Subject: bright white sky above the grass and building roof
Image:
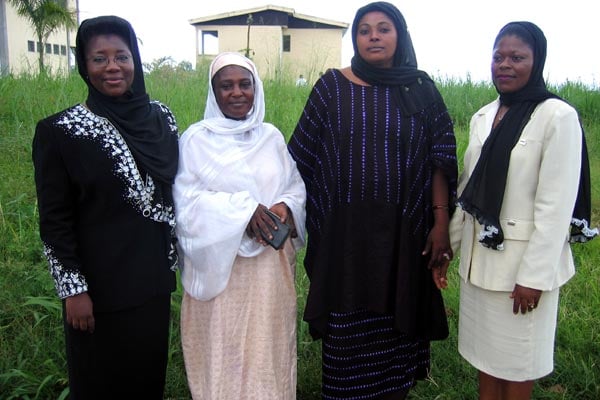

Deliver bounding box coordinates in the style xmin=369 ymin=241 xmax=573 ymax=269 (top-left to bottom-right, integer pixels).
xmin=79 ymin=0 xmax=600 ymax=87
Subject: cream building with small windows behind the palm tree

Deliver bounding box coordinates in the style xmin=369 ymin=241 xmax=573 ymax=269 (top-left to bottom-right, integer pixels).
xmin=0 ymin=0 xmax=79 ymax=75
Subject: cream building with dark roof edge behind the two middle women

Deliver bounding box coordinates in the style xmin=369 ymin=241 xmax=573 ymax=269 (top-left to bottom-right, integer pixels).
xmin=189 ymin=5 xmax=349 ymax=82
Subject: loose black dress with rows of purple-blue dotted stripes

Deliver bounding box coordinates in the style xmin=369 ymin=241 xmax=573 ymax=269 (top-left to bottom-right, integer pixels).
xmin=288 ymin=70 xmax=457 ymax=398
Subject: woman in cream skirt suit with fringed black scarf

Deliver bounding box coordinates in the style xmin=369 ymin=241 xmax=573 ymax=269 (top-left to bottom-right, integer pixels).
xmin=451 ymin=22 xmax=598 ymax=400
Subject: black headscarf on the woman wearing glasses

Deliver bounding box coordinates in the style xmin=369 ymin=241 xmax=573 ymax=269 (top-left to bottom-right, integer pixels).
xmin=75 ymin=16 xmax=178 ymax=184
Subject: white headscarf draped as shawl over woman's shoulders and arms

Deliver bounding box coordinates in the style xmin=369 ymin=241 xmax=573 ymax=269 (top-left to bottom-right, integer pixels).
xmin=173 ymin=53 xmax=306 ymax=300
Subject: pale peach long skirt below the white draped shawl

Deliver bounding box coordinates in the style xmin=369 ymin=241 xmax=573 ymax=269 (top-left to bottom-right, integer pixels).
xmin=181 ymin=241 xmax=297 ymax=400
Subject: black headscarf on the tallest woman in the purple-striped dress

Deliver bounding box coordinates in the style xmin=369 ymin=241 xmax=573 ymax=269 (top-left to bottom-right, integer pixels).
xmin=351 ymin=1 xmax=443 ymax=116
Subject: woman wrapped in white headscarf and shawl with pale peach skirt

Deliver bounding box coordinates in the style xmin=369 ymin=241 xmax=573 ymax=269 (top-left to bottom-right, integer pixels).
xmin=174 ymin=53 xmax=306 ymax=400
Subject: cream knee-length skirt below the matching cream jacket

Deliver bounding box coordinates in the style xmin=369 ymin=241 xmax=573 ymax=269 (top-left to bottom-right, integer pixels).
xmin=458 ymin=281 xmax=559 ymax=382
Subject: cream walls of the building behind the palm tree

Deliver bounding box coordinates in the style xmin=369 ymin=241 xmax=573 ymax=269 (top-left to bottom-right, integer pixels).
xmin=0 ymin=0 xmax=76 ymax=75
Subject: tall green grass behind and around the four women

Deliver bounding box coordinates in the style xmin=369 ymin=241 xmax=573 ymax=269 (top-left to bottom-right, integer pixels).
xmin=0 ymin=68 xmax=600 ymax=400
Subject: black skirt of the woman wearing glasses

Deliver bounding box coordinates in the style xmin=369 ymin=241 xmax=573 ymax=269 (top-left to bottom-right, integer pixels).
xmin=63 ymin=294 xmax=171 ymax=400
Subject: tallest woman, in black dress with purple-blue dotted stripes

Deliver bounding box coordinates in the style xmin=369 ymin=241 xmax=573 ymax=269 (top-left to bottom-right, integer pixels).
xmin=289 ymin=2 xmax=457 ymax=399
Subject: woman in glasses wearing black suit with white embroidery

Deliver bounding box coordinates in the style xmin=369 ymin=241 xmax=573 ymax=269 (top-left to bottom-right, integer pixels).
xmin=33 ymin=16 xmax=178 ymax=400
